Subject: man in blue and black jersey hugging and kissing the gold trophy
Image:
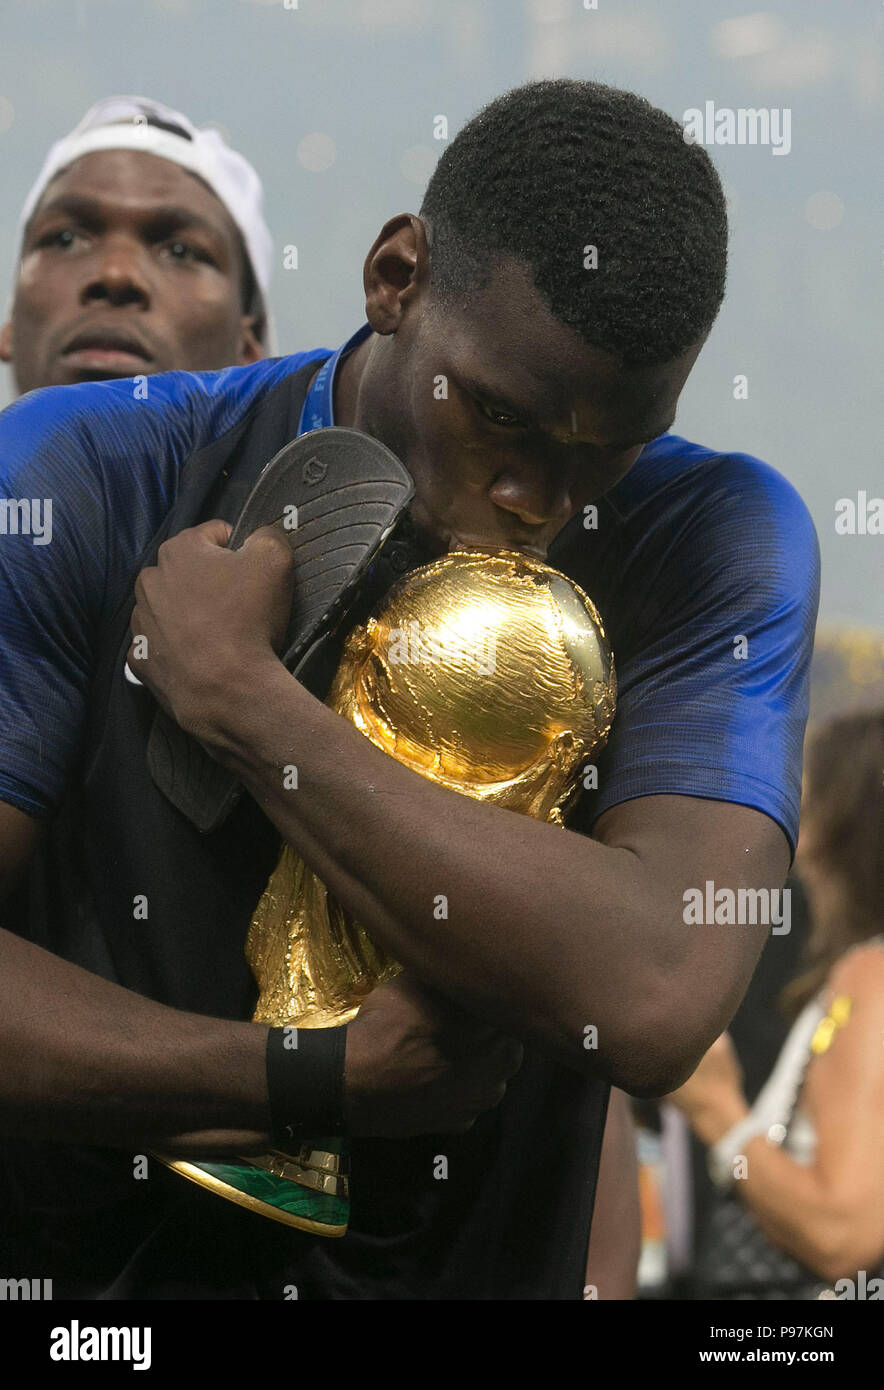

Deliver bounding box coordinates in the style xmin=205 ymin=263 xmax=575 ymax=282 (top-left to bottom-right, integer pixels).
xmin=0 ymin=82 xmax=817 ymax=1298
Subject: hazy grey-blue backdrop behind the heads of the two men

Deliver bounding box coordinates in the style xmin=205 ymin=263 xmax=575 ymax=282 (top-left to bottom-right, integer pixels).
xmin=0 ymin=0 xmax=884 ymax=627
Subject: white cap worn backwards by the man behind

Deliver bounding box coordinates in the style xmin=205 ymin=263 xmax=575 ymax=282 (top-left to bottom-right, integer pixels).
xmin=18 ymin=96 xmax=274 ymax=349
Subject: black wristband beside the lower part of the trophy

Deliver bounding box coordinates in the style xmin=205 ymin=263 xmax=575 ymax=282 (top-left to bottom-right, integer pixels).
xmin=267 ymin=1024 xmax=347 ymax=1147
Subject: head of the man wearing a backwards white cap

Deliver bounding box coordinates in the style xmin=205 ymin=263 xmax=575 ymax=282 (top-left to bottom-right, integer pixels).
xmin=0 ymin=96 xmax=272 ymax=393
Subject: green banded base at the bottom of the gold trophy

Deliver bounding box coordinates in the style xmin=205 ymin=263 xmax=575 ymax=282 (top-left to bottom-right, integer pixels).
xmin=154 ymin=1140 xmax=350 ymax=1238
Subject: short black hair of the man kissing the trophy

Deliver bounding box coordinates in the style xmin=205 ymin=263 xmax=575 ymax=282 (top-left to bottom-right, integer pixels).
xmin=420 ymin=78 xmax=727 ymax=366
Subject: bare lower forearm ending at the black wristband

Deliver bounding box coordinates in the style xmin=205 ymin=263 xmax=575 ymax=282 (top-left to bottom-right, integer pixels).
xmin=0 ymin=931 xmax=270 ymax=1156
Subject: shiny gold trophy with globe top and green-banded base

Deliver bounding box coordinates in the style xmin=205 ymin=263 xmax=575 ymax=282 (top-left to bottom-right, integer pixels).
xmin=164 ymin=550 xmax=617 ymax=1236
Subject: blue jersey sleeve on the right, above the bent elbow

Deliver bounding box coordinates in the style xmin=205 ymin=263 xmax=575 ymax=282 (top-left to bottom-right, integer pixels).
xmin=577 ymin=455 xmax=819 ymax=852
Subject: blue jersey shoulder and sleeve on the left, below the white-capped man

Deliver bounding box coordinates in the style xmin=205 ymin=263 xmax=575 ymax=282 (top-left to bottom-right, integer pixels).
xmin=0 ymin=349 xmax=327 ymax=816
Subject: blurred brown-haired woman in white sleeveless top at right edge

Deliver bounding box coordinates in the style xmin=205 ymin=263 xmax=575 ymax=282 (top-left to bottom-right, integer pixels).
xmin=669 ymin=710 xmax=884 ymax=1298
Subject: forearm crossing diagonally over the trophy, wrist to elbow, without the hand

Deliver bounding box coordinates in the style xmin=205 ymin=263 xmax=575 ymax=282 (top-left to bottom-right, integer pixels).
xmin=201 ymin=662 xmax=663 ymax=1084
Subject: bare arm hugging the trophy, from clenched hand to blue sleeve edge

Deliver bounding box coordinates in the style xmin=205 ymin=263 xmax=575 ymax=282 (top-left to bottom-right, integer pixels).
xmin=129 ymin=505 xmax=788 ymax=1095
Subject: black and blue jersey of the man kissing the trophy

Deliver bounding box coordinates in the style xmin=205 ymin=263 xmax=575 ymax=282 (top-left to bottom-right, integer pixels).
xmin=0 ymin=331 xmax=817 ymax=1300
